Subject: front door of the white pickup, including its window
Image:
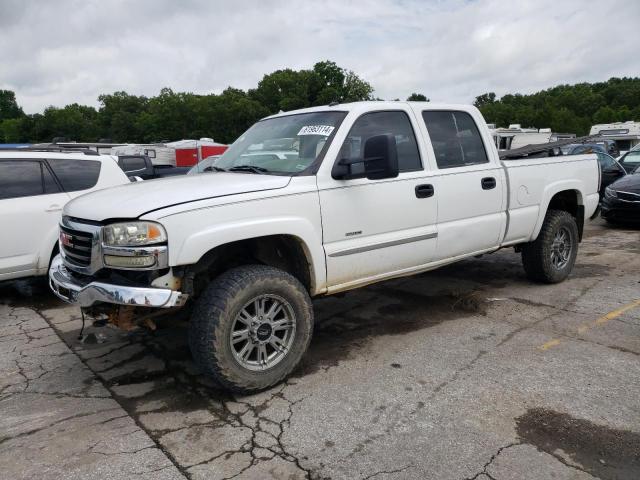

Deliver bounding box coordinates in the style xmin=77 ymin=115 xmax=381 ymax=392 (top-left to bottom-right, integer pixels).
xmin=318 ymin=107 xmax=437 ymax=291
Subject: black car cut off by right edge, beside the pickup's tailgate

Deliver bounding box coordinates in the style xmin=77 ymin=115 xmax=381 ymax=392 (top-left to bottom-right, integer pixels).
xmin=601 ymin=169 xmax=640 ymax=223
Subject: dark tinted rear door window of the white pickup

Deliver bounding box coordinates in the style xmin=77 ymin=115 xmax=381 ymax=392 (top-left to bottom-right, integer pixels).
xmin=422 ymin=111 xmax=489 ymax=168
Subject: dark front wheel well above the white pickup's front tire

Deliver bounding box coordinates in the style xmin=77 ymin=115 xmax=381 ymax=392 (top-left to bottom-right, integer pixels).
xmin=185 ymin=235 xmax=313 ymax=296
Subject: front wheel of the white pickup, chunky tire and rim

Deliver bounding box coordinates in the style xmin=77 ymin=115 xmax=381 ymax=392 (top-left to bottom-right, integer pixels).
xmin=189 ymin=265 xmax=313 ymax=393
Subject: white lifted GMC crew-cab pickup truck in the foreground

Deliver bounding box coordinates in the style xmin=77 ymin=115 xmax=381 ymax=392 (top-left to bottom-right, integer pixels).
xmin=49 ymin=102 xmax=599 ymax=392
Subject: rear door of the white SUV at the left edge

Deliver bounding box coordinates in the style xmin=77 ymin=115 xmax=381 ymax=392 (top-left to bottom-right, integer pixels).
xmin=0 ymin=160 xmax=69 ymax=280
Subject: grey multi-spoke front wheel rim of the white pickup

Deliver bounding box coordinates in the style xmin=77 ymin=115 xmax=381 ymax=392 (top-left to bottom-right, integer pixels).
xmin=229 ymin=294 xmax=296 ymax=371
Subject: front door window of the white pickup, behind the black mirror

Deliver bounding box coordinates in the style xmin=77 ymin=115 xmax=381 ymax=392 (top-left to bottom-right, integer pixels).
xmin=340 ymin=112 xmax=422 ymax=172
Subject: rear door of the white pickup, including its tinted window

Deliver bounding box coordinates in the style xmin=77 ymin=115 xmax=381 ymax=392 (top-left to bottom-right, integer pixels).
xmin=421 ymin=110 xmax=506 ymax=260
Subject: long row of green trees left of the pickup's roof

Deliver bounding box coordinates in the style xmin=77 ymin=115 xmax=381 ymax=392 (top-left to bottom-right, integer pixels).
xmin=0 ymin=61 xmax=373 ymax=143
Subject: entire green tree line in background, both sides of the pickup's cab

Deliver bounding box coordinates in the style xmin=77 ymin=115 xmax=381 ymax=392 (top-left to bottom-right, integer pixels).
xmin=5 ymin=69 xmax=640 ymax=143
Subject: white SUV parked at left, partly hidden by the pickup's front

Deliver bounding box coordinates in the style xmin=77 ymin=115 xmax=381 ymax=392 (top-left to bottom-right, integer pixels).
xmin=0 ymin=150 xmax=130 ymax=281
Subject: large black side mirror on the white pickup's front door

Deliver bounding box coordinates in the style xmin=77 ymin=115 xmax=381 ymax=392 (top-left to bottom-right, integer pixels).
xmin=331 ymin=134 xmax=398 ymax=180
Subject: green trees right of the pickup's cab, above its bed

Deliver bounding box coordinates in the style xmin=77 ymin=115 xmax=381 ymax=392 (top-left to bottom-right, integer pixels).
xmin=474 ymin=78 xmax=640 ymax=135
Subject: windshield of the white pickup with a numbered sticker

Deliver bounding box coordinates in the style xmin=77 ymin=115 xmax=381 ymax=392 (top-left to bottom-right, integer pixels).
xmin=214 ymin=112 xmax=346 ymax=175
